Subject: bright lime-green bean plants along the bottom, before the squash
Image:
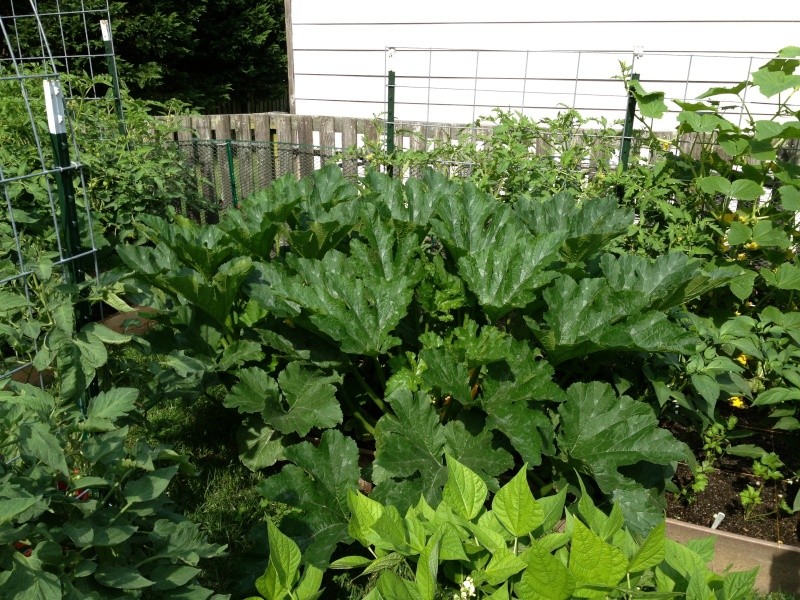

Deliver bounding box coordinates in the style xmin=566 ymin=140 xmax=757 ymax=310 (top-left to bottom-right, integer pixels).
xmin=250 ymin=458 xmax=757 ymax=600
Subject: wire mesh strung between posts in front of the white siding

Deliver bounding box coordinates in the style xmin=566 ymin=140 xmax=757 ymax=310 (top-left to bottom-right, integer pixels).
xmin=382 ymin=47 xmax=800 ymax=130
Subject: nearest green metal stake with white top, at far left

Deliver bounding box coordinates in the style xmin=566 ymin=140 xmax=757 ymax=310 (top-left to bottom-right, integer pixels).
xmin=43 ymin=79 xmax=90 ymax=411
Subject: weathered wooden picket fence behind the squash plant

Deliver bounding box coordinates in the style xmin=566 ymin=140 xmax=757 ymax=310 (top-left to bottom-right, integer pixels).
xmin=162 ymin=112 xmax=764 ymax=208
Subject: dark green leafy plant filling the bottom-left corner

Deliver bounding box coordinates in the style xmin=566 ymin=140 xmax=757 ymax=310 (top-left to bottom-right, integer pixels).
xmin=0 ymin=384 xmax=224 ymax=599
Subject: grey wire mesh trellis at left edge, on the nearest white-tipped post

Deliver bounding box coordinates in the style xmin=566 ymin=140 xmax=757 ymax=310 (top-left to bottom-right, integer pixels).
xmin=0 ymin=0 xmax=108 ymax=384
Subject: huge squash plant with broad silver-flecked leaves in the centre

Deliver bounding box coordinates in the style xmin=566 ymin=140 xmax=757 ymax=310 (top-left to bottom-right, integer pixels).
xmin=119 ymin=165 xmax=740 ymax=566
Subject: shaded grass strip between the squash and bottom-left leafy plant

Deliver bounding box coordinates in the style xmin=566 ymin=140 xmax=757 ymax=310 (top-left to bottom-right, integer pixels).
xmin=112 ymin=346 xmax=290 ymax=598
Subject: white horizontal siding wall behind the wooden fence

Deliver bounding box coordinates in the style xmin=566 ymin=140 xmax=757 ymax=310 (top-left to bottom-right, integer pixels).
xmin=290 ymin=0 xmax=800 ymax=126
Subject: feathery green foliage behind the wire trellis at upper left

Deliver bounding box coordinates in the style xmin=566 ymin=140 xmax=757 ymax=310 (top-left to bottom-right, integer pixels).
xmin=0 ymin=67 xmax=205 ymax=266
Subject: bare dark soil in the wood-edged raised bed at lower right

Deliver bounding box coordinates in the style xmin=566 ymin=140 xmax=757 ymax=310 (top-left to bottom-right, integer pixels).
xmin=667 ymin=418 xmax=800 ymax=547
